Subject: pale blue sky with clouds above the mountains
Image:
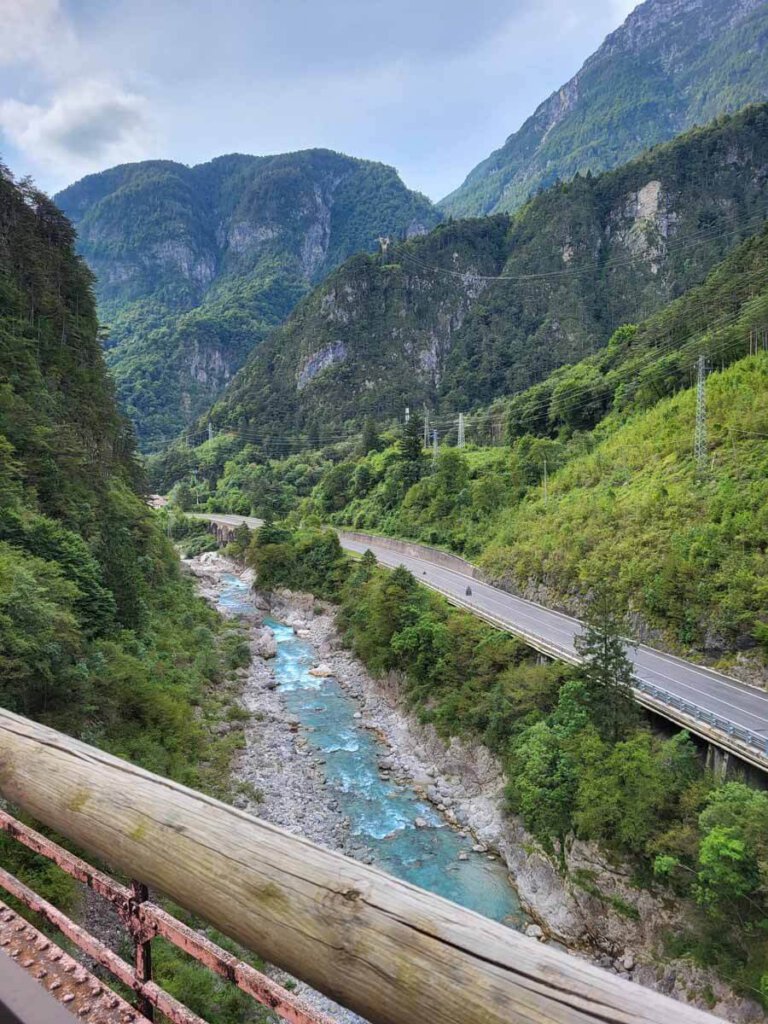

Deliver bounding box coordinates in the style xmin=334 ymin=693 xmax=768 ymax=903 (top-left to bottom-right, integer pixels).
xmin=0 ymin=0 xmax=636 ymax=200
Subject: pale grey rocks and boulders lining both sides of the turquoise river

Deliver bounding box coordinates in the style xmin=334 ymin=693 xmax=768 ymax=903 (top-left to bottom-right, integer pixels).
xmin=191 ymin=555 xmax=766 ymax=1024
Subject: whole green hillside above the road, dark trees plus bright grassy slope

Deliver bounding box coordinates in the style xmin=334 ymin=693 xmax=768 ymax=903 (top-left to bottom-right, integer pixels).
xmin=290 ymin=221 xmax=768 ymax=658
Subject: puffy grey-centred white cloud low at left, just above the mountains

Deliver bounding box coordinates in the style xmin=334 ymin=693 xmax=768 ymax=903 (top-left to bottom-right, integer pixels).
xmin=0 ymin=80 xmax=154 ymax=176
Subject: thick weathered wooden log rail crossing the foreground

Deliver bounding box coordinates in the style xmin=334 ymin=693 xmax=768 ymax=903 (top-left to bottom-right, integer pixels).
xmin=0 ymin=711 xmax=714 ymax=1024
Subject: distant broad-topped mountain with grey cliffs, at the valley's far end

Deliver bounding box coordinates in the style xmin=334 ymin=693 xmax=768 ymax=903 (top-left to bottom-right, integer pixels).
xmin=55 ymin=150 xmax=439 ymax=446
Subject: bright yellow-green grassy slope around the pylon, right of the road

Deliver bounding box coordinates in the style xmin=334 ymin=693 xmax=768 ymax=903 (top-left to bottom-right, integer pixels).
xmin=482 ymin=353 xmax=768 ymax=649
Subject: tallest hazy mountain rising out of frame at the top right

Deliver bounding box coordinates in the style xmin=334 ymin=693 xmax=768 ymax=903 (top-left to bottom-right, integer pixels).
xmin=438 ymin=0 xmax=768 ymax=217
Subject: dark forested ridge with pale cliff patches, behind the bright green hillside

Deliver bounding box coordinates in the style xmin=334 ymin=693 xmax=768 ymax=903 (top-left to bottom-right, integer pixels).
xmin=204 ymin=105 xmax=768 ymax=440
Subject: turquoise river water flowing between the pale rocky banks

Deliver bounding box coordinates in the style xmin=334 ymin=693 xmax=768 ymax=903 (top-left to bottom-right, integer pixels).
xmin=217 ymin=572 xmax=526 ymax=929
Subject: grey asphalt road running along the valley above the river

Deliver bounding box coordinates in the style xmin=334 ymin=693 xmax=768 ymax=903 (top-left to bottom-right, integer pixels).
xmin=196 ymin=515 xmax=768 ymax=764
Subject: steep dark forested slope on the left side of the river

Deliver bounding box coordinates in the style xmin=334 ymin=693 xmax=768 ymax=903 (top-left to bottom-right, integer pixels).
xmin=0 ymin=168 xmax=270 ymax=1024
